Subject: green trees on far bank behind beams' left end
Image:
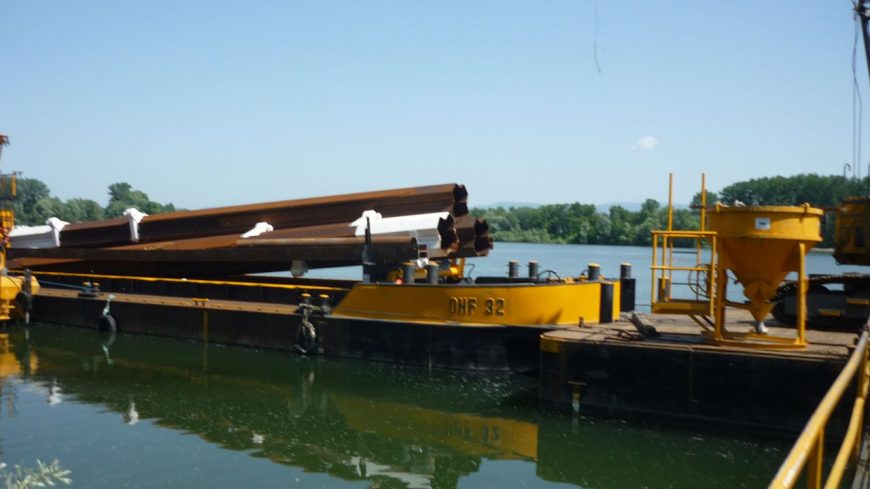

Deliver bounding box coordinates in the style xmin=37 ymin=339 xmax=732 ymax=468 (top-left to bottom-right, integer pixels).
xmin=12 ymin=178 xmax=176 ymax=226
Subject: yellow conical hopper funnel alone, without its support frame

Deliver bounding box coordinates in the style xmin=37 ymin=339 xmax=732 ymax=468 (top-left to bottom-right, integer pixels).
xmin=709 ymin=204 xmax=823 ymax=321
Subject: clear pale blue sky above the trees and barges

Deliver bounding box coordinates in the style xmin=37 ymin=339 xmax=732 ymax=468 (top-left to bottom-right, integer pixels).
xmin=0 ymin=0 xmax=870 ymax=208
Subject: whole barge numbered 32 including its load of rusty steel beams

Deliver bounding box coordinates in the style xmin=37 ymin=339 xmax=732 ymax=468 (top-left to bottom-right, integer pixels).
xmin=3 ymin=153 xmax=633 ymax=371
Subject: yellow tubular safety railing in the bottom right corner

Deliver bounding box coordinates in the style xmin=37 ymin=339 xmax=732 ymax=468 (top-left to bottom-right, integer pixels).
xmin=770 ymin=321 xmax=870 ymax=489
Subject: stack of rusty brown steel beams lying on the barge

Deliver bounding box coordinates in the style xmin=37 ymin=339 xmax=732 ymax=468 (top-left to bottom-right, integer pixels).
xmin=10 ymin=184 xmax=492 ymax=277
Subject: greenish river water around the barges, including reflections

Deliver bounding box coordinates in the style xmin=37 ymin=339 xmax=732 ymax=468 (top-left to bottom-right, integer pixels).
xmin=0 ymin=243 xmax=860 ymax=489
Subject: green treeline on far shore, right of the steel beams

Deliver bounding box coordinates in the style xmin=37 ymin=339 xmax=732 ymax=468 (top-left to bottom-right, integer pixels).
xmin=472 ymin=174 xmax=870 ymax=246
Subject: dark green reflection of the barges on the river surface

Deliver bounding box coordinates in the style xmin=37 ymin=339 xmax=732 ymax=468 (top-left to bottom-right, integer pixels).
xmin=0 ymin=326 xmax=785 ymax=488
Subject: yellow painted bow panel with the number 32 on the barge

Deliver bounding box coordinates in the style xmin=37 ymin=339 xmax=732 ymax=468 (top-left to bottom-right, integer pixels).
xmin=333 ymin=281 xmax=619 ymax=326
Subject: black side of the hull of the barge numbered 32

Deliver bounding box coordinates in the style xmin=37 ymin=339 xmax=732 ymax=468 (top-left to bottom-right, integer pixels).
xmin=32 ymin=295 xmax=552 ymax=372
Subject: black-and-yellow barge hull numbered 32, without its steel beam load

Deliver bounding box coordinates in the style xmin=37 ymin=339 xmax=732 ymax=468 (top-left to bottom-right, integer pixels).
xmin=27 ymin=266 xmax=621 ymax=371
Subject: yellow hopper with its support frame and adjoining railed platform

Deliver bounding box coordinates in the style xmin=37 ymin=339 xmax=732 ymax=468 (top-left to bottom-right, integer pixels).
xmin=650 ymin=175 xmax=823 ymax=348
